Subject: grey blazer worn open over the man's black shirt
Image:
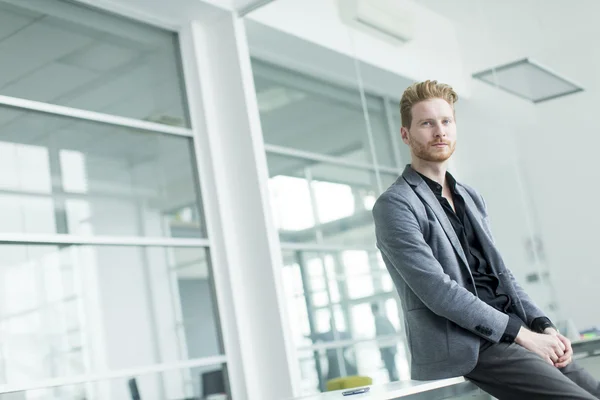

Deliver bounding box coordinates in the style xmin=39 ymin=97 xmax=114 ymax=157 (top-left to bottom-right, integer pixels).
xmin=373 ymin=166 xmax=544 ymax=380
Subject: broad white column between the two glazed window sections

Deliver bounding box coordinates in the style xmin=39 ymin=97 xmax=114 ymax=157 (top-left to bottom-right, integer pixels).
xmin=181 ymin=11 xmax=299 ymax=400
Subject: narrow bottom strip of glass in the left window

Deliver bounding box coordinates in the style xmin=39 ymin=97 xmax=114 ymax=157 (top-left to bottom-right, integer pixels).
xmin=8 ymin=365 xmax=229 ymax=400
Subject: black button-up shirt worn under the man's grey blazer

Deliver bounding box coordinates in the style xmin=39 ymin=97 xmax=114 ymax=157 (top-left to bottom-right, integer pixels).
xmin=419 ymin=172 xmax=553 ymax=347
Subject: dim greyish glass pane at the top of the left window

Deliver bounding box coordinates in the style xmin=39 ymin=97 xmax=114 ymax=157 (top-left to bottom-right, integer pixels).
xmin=0 ymin=0 xmax=188 ymax=126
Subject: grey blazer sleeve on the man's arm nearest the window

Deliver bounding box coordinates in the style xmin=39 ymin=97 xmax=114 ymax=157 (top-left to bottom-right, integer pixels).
xmin=373 ymin=191 xmax=509 ymax=343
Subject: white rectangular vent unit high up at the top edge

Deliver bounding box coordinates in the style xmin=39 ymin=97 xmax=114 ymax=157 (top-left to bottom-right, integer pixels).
xmin=338 ymin=0 xmax=414 ymax=45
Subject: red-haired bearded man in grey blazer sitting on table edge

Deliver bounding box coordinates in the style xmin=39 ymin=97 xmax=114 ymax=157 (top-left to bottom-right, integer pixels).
xmin=373 ymin=81 xmax=600 ymax=400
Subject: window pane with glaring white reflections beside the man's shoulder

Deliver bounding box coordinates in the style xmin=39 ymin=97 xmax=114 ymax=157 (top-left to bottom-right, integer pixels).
xmin=267 ymin=154 xmax=379 ymax=246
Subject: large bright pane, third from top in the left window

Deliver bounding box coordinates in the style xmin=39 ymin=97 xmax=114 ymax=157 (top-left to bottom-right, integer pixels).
xmin=0 ymin=245 xmax=221 ymax=384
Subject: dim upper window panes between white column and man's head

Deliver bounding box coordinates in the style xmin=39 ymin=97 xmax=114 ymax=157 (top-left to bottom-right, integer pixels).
xmin=252 ymin=60 xmax=394 ymax=165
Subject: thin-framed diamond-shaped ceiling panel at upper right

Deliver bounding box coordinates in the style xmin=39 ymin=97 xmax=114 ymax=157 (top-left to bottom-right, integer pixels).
xmin=473 ymin=58 xmax=583 ymax=103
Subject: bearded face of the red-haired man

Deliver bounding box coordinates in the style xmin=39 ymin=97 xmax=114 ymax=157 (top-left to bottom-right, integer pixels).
xmin=401 ymin=99 xmax=456 ymax=162
